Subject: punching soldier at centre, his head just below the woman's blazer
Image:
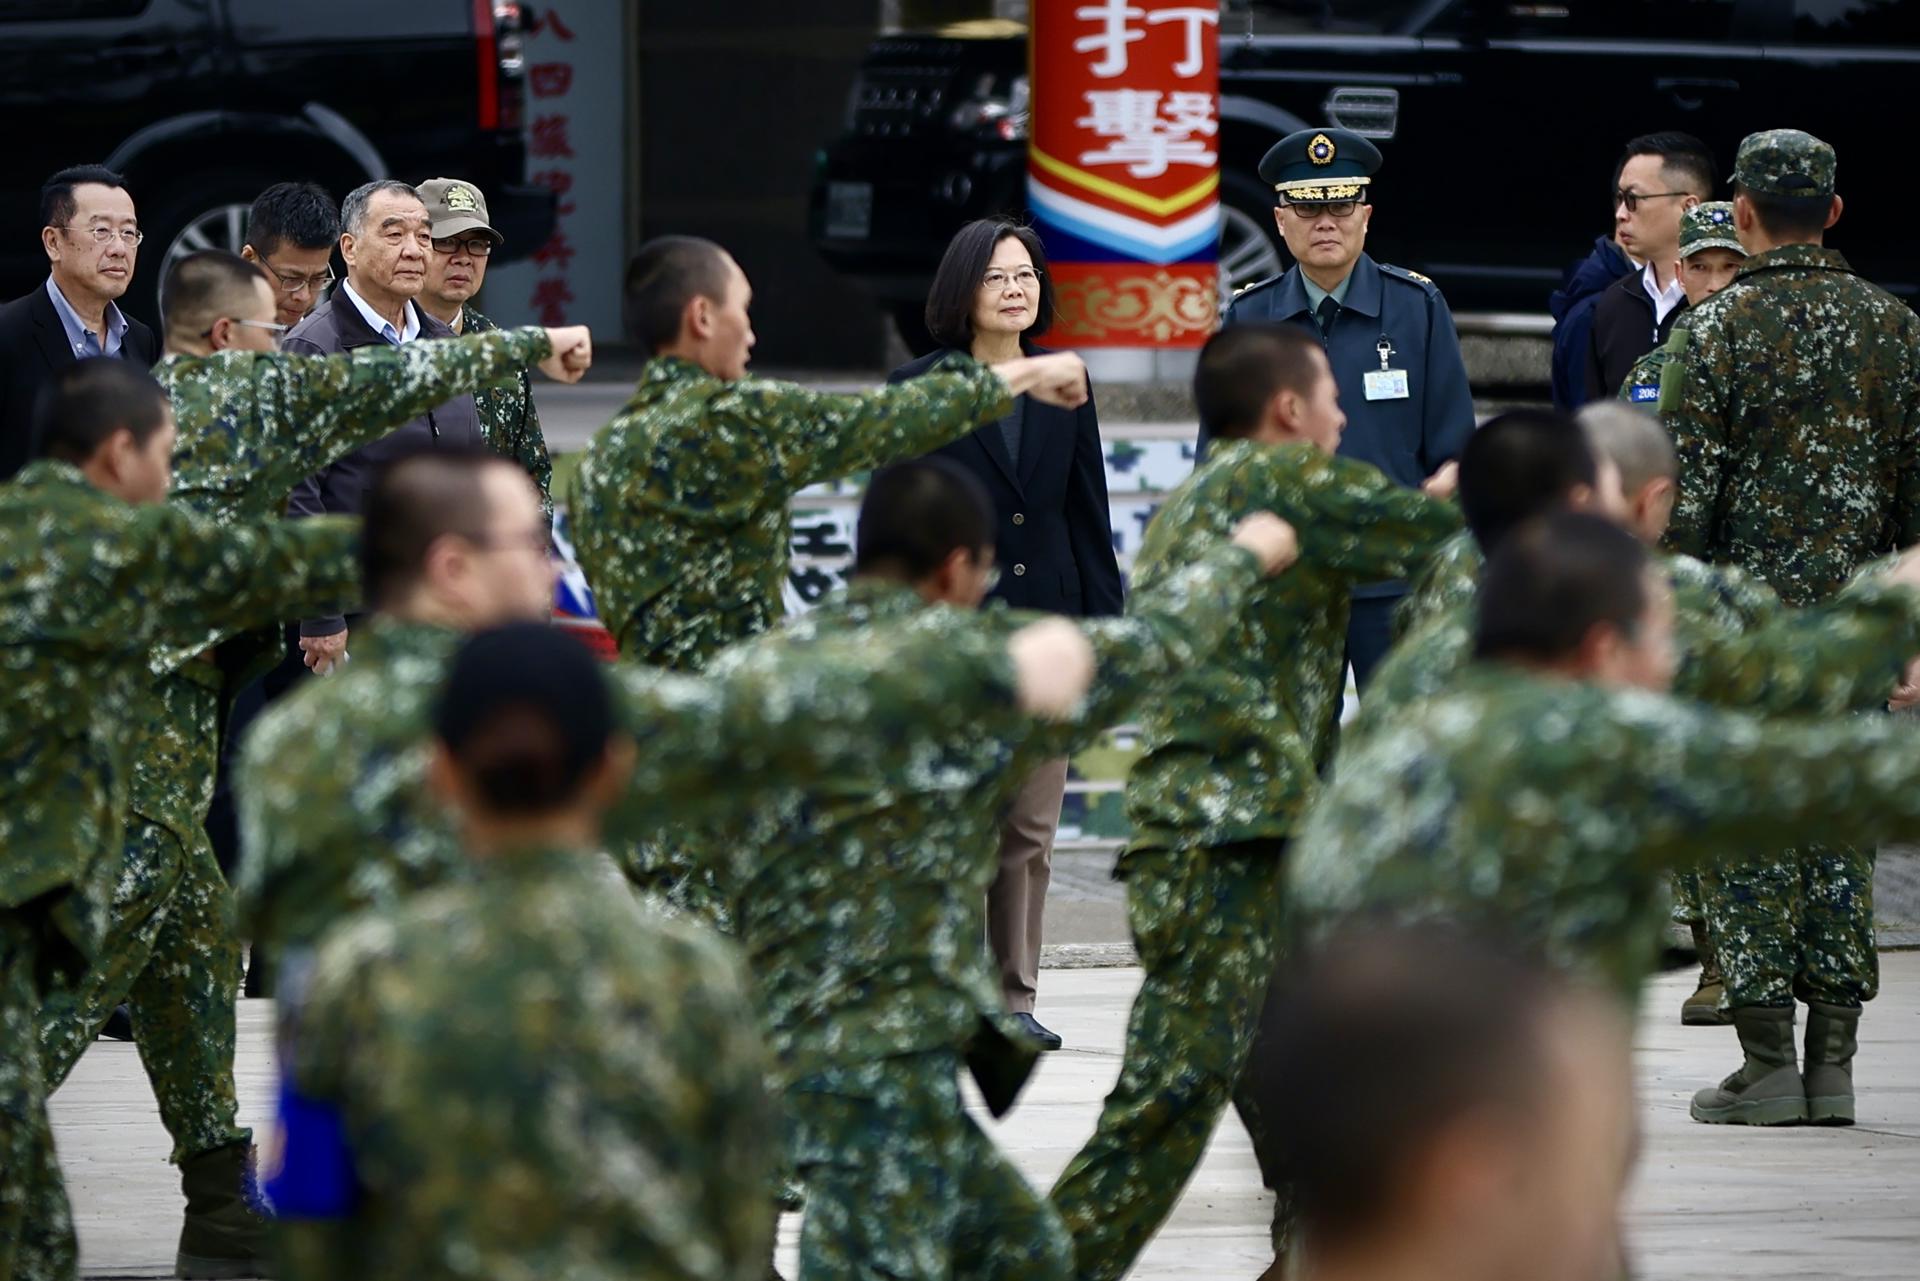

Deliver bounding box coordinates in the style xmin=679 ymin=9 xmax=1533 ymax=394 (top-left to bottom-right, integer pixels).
xmin=708 ymin=459 xmax=1294 ymax=1281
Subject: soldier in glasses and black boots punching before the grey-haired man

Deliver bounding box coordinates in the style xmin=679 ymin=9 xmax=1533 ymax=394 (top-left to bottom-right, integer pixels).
xmin=24 ymin=250 xmax=586 ymax=1275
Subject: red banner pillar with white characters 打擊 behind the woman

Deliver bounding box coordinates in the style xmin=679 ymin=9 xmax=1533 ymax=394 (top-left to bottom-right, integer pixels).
xmin=1027 ymin=0 xmax=1219 ymax=348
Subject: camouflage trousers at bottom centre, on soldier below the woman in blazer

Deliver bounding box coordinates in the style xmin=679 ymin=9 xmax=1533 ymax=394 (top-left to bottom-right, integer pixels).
xmin=785 ymin=1051 xmax=1073 ymax=1281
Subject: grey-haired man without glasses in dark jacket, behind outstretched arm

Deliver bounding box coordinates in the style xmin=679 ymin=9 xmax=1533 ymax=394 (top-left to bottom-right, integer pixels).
xmin=284 ymin=179 xmax=486 ymax=670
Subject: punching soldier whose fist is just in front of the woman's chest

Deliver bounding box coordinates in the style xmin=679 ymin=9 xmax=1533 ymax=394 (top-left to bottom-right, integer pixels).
xmin=568 ymin=236 xmax=1087 ymax=924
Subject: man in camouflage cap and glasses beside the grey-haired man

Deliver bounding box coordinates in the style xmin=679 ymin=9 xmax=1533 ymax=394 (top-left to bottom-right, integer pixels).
xmin=420 ymin=179 xmax=553 ymax=520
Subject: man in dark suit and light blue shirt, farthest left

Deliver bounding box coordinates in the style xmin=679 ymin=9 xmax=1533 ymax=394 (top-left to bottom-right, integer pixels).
xmin=0 ymin=165 xmax=159 ymax=480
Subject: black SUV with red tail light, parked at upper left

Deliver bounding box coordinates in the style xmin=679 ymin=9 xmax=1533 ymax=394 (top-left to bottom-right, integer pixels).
xmin=0 ymin=0 xmax=555 ymax=323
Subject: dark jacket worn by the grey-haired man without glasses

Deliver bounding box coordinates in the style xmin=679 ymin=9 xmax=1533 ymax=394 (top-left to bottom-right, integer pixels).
xmin=282 ymin=282 xmax=486 ymax=636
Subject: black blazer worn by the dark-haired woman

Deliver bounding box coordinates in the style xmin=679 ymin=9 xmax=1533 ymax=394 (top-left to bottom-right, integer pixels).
xmin=887 ymin=344 xmax=1125 ymax=616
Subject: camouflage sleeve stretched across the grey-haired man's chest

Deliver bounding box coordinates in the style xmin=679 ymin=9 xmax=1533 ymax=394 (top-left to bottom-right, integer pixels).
xmin=253 ymin=326 xmax=553 ymax=494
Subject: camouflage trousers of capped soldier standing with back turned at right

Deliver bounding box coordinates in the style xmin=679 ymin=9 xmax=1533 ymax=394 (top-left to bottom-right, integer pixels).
xmin=1703 ymin=845 xmax=1880 ymax=1006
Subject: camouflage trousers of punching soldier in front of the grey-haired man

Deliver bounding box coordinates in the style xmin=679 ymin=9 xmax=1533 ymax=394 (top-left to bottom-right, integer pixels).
xmin=40 ymin=814 xmax=253 ymax=1164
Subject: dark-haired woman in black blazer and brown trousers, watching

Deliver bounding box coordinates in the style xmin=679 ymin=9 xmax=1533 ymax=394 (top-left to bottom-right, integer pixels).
xmin=891 ymin=219 xmax=1125 ymax=1049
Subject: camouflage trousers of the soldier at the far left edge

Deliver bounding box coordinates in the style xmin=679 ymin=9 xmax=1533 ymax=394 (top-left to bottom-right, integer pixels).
xmin=0 ymin=908 xmax=81 ymax=1281
